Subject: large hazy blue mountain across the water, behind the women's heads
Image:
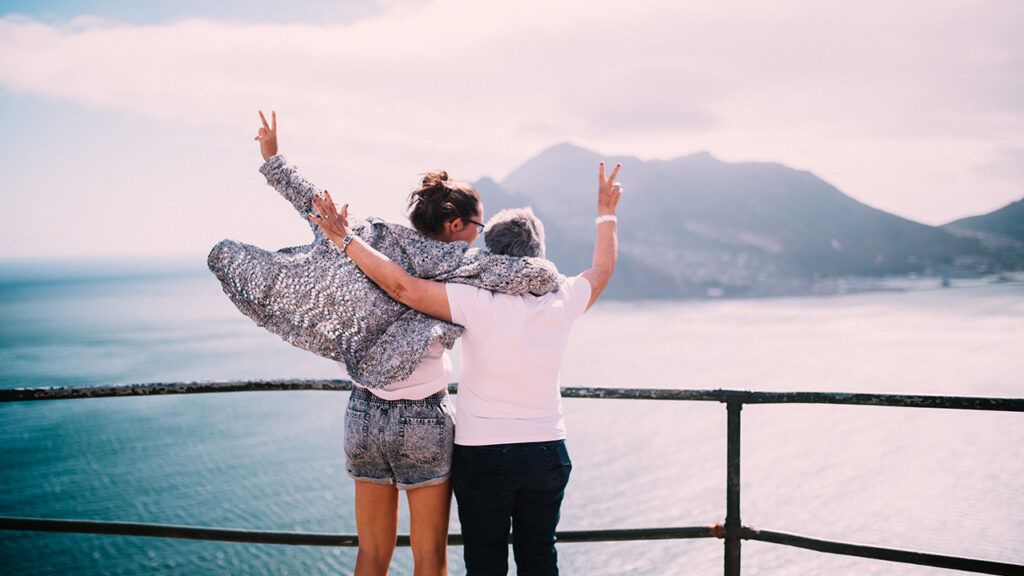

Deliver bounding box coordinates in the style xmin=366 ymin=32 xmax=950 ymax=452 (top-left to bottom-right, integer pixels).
xmin=475 ymin=143 xmax=995 ymax=297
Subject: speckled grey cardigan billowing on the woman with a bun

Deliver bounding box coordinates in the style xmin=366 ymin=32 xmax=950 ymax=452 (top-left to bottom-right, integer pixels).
xmin=207 ymin=156 xmax=561 ymax=388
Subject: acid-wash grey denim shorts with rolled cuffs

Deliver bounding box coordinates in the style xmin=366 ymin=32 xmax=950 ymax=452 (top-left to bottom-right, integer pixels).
xmin=345 ymin=386 xmax=455 ymax=490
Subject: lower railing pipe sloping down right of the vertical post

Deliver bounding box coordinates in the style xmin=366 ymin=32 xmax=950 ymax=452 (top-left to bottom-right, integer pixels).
xmin=743 ymin=527 xmax=1024 ymax=576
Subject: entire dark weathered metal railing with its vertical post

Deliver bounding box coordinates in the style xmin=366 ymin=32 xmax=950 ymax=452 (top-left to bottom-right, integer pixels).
xmin=0 ymin=380 xmax=1024 ymax=576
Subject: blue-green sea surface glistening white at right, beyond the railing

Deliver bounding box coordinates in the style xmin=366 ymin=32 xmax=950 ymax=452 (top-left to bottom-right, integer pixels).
xmin=0 ymin=263 xmax=1024 ymax=575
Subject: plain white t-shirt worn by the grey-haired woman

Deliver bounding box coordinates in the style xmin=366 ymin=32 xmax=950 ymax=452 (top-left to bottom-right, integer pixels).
xmin=445 ymin=276 xmax=591 ymax=446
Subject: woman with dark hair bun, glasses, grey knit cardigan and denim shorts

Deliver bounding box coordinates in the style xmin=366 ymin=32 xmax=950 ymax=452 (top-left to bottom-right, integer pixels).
xmin=208 ymin=112 xmax=559 ymax=576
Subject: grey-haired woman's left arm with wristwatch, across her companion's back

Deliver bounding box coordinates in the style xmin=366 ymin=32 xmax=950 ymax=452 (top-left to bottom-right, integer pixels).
xmin=309 ymin=191 xmax=452 ymax=322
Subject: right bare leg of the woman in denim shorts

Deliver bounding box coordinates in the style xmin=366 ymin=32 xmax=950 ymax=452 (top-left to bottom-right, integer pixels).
xmin=407 ymin=481 xmax=452 ymax=576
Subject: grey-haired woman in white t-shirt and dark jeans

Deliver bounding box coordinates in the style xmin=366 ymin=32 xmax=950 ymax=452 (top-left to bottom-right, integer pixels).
xmin=309 ymin=162 xmax=622 ymax=576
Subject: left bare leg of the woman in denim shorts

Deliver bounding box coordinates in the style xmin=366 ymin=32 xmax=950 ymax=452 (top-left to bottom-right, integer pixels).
xmin=354 ymin=481 xmax=397 ymax=576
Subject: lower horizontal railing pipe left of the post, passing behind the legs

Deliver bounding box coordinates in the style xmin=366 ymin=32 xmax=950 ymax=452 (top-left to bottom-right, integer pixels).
xmin=0 ymin=517 xmax=714 ymax=546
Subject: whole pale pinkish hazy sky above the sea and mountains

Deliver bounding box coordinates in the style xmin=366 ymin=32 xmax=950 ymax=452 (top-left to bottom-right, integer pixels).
xmin=0 ymin=0 xmax=1024 ymax=257
